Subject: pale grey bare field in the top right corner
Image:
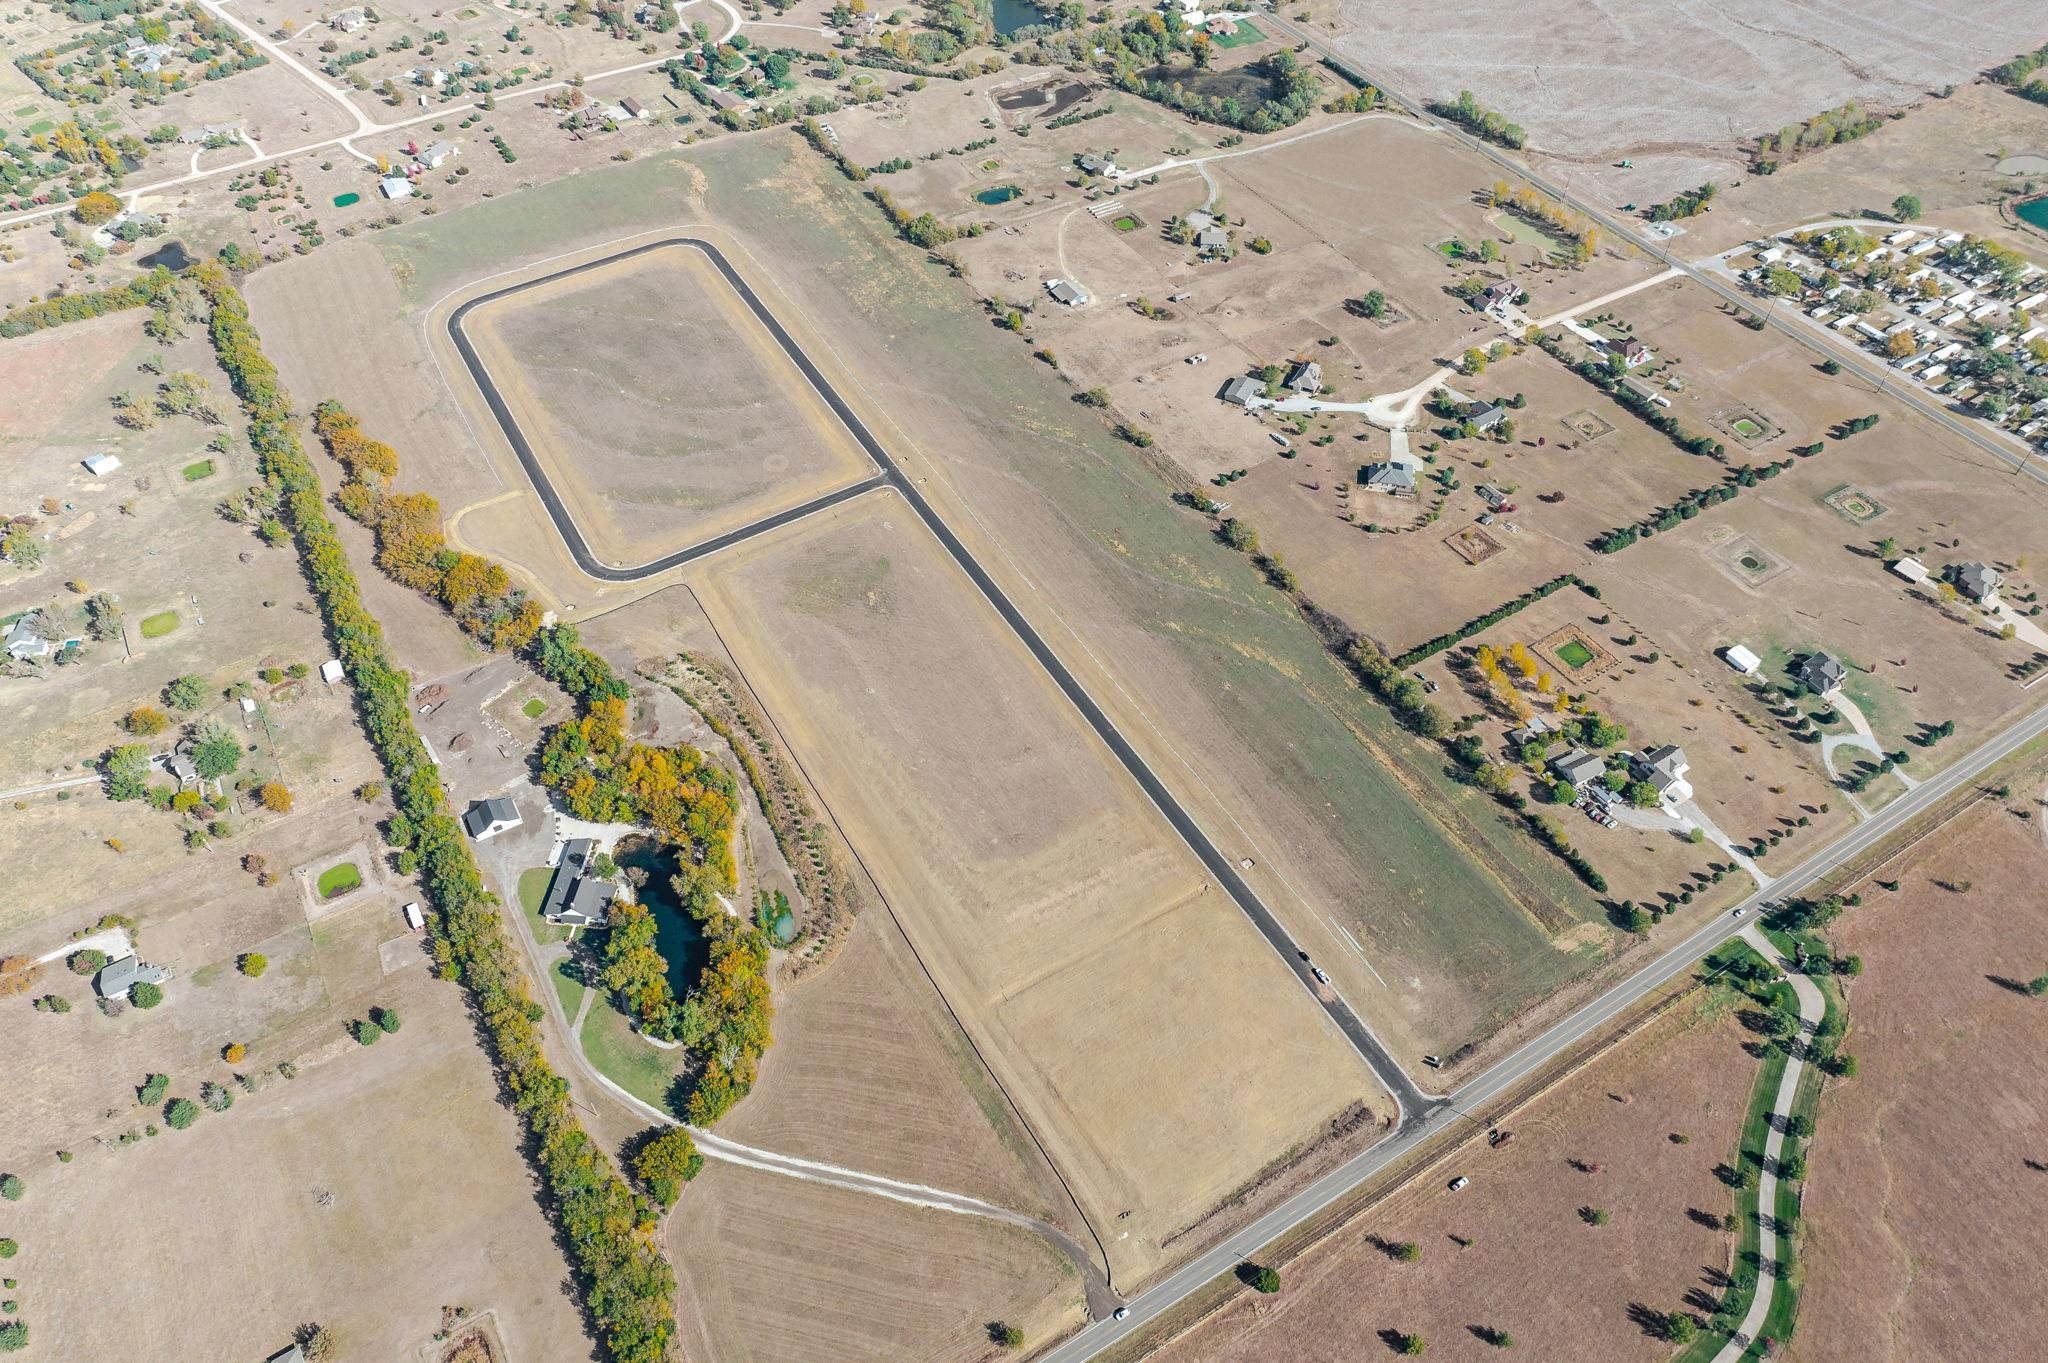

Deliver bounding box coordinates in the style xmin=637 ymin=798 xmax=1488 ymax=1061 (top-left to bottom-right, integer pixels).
xmin=1335 ymin=0 xmax=2042 ymax=201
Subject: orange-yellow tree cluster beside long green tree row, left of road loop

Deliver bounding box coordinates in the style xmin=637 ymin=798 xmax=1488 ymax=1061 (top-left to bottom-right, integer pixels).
xmin=313 ymin=401 xmax=545 ymax=649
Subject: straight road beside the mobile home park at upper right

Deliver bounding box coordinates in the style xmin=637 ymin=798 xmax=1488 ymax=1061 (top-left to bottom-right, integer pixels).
xmin=1260 ymin=14 xmax=2048 ymax=483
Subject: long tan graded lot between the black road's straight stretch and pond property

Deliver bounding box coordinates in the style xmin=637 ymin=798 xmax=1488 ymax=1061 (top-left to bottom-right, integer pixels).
xmin=700 ymin=495 xmax=1386 ymax=1281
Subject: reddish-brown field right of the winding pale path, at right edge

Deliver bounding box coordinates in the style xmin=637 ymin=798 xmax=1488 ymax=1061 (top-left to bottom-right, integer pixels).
xmin=1790 ymin=798 xmax=2048 ymax=1363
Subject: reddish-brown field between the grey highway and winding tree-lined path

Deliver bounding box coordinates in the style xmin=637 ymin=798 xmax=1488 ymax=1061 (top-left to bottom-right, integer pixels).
xmin=1153 ymin=1003 xmax=1755 ymax=1363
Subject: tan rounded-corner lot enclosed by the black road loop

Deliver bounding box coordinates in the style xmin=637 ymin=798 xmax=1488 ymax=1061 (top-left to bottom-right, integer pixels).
xmin=467 ymin=246 xmax=872 ymax=563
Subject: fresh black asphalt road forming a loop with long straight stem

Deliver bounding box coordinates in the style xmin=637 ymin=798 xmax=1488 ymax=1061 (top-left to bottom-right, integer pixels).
xmin=449 ymin=237 xmax=1434 ymax=1119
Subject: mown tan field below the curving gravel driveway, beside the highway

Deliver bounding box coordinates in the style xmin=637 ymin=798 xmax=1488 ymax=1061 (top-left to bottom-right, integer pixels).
xmin=668 ymin=1154 xmax=1081 ymax=1361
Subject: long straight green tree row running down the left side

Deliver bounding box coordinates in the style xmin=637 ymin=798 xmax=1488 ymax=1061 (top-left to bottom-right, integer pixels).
xmin=193 ymin=262 xmax=676 ymax=1363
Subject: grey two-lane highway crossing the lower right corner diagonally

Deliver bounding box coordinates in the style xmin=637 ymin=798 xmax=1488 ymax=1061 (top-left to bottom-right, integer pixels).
xmin=1040 ymin=691 xmax=2048 ymax=1363
